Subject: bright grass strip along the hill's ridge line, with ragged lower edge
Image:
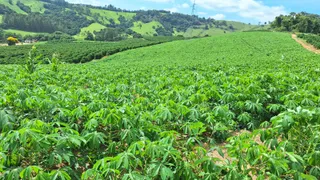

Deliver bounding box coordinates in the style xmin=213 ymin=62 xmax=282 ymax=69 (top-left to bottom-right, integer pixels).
xmin=90 ymin=8 xmax=136 ymax=24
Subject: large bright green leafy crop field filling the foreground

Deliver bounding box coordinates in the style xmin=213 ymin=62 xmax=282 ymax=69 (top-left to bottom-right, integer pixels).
xmin=0 ymin=32 xmax=320 ymax=180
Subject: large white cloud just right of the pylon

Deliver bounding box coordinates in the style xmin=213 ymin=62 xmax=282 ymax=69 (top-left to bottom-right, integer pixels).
xmin=190 ymin=0 xmax=287 ymax=22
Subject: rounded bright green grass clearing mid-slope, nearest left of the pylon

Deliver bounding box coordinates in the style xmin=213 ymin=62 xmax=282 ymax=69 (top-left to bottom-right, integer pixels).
xmin=131 ymin=21 xmax=162 ymax=36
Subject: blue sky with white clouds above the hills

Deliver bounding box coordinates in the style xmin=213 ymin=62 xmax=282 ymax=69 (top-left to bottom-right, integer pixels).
xmin=66 ymin=0 xmax=320 ymax=24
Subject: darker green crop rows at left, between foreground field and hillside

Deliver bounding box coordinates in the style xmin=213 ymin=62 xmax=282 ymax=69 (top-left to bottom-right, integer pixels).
xmin=0 ymin=37 xmax=183 ymax=64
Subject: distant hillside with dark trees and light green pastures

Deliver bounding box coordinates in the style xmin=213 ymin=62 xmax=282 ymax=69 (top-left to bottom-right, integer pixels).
xmin=0 ymin=0 xmax=269 ymax=39
